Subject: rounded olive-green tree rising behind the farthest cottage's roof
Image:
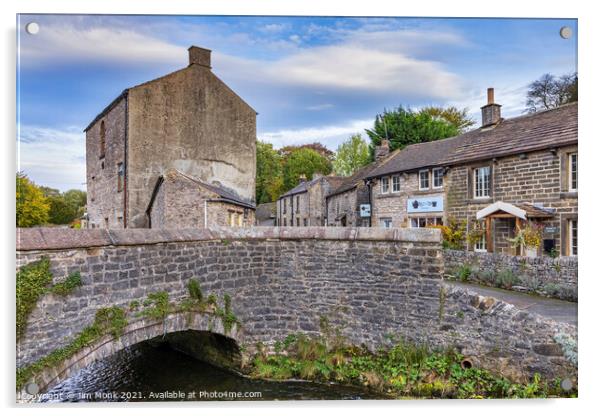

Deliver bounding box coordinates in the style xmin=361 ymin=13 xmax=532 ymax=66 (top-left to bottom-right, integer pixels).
xmin=283 ymin=148 xmax=332 ymax=192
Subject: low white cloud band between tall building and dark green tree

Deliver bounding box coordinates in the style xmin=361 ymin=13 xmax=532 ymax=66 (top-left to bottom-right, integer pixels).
xmin=259 ymin=119 xmax=374 ymax=150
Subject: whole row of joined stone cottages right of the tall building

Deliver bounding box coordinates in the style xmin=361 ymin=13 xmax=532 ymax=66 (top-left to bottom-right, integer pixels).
xmin=276 ymin=89 xmax=578 ymax=256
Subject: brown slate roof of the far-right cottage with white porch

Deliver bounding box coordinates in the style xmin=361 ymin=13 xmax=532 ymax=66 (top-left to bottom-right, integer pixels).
xmin=442 ymin=102 xmax=578 ymax=165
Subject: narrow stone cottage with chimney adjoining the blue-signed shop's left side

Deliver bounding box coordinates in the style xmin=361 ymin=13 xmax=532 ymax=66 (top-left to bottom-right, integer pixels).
xmin=326 ymin=140 xmax=398 ymax=227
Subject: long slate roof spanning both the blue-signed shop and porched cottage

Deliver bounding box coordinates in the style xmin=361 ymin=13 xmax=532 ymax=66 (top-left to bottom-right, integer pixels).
xmin=368 ymin=102 xmax=577 ymax=178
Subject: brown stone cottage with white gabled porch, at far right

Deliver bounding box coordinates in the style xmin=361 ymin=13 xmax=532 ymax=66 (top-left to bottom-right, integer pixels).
xmin=442 ymin=89 xmax=578 ymax=256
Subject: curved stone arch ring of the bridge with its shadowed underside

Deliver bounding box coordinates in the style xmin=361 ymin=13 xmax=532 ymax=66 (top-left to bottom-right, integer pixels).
xmin=24 ymin=312 xmax=243 ymax=396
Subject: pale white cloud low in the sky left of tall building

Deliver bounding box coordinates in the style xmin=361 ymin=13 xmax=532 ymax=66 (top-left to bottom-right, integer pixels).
xmin=17 ymin=126 xmax=86 ymax=191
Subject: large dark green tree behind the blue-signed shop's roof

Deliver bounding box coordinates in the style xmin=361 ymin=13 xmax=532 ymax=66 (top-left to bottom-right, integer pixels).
xmin=366 ymin=106 xmax=461 ymax=153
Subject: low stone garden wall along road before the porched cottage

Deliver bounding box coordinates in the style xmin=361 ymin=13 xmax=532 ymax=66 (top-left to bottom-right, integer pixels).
xmin=443 ymin=250 xmax=578 ymax=301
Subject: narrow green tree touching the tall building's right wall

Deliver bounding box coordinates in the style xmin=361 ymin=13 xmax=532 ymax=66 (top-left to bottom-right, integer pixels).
xmin=255 ymin=140 xmax=284 ymax=204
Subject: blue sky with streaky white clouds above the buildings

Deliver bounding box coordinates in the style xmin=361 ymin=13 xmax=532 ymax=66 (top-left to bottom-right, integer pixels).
xmin=17 ymin=15 xmax=577 ymax=191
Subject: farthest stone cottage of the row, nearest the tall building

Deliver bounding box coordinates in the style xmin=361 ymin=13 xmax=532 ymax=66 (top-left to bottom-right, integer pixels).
xmin=276 ymin=173 xmax=343 ymax=227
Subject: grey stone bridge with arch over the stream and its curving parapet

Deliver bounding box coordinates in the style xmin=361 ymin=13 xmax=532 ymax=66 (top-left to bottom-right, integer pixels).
xmin=17 ymin=227 xmax=576 ymax=400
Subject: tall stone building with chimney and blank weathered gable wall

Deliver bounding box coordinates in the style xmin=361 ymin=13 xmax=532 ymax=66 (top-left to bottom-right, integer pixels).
xmin=85 ymin=46 xmax=257 ymax=228
